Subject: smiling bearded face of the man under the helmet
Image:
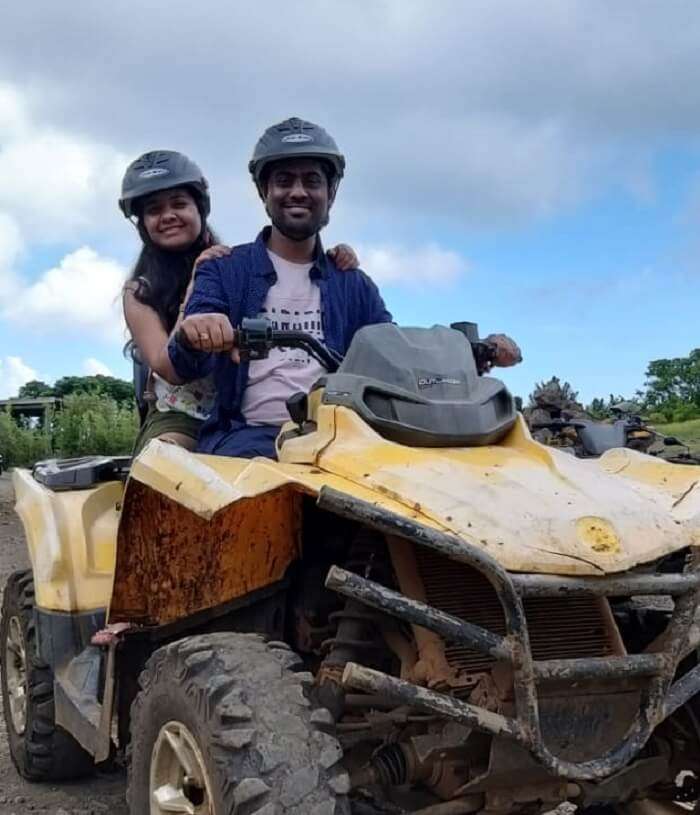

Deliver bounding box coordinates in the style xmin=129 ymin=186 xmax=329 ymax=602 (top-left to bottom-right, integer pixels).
xmin=264 ymin=158 xmax=333 ymax=241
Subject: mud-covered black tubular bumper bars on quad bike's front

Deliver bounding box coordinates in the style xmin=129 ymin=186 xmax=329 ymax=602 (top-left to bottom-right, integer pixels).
xmin=318 ymin=487 xmax=700 ymax=780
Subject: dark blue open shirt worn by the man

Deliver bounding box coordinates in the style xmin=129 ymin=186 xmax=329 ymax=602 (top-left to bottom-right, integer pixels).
xmin=168 ymin=227 xmax=392 ymax=453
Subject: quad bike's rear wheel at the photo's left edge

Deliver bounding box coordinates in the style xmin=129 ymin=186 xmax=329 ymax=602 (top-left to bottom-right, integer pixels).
xmin=0 ymin=571 xmax=95 ymax=781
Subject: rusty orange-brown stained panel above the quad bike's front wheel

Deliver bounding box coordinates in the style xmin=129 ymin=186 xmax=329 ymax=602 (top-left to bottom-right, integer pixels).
xmin=109 ymin=481 xmax=301 ymax=625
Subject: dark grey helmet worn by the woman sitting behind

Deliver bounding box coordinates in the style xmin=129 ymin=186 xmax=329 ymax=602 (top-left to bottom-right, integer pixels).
xmin=119 ymin=150 xmax=211 ymax=218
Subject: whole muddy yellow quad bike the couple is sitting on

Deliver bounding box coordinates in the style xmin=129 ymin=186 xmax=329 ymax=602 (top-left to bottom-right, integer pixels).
xmin=0 ymin=322 xmax=700 ymax=815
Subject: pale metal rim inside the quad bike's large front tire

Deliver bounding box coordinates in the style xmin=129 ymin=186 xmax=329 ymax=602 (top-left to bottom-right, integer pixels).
xmin=150 ymin=721 xmax=214 ymax=815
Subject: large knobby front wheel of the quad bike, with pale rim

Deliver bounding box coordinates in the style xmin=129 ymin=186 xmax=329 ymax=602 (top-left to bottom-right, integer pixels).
xmin=127 ymin=633 xmax=350 ymax=815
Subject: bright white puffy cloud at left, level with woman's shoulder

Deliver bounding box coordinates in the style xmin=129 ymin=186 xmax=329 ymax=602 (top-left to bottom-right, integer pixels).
xmin=2 ymin=246 xmax=126 ymax=342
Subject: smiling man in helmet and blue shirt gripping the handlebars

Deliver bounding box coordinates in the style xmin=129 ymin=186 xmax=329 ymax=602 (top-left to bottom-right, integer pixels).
xmin=167 ymin=118 xmax=519 ymax=458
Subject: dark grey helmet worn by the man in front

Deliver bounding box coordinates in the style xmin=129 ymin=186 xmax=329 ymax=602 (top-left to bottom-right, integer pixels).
xmin=248 ymin=116 xmax=345 ymax=189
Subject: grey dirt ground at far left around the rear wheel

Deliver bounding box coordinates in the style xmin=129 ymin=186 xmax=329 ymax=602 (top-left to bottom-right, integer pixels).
xmin=0 ymin=473 xmax=128 ymax=815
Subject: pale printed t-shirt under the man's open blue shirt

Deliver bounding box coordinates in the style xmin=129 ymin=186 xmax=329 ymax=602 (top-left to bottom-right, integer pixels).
xmin=242 ymin=250 xmax=326 ymax=425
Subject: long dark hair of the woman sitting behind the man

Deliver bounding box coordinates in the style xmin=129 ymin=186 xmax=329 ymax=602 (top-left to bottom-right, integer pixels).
xmin=127 ymin=190 xmax=219 ymax=338
